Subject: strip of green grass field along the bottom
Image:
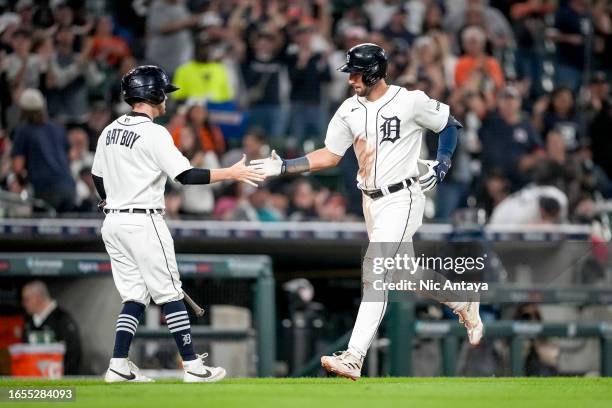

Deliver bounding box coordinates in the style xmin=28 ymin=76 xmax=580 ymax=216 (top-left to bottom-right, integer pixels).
xmin=0 ymin=378 xmax=612 ymax=408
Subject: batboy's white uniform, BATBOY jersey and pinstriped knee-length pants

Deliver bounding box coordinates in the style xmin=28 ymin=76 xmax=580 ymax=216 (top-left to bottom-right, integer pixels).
xmin=91 ymin=113 xmax=192 ymax=305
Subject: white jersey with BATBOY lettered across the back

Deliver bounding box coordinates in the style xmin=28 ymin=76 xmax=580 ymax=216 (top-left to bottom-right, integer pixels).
xmin=91 ymin=113 xmax=192 ymax=209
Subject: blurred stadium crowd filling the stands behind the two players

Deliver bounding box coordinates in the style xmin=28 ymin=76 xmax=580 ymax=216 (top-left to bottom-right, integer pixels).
xmin=0 ymin=0 xmax=612 ymax=224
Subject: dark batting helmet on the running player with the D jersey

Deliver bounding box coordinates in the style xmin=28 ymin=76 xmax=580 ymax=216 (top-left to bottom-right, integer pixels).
xmin=338 ymin=43 xmax=387 ymax=86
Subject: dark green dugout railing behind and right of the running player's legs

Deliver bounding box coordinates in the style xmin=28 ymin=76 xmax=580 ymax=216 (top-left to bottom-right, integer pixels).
xmin=292 ymin=286 xmax=612 ymax=377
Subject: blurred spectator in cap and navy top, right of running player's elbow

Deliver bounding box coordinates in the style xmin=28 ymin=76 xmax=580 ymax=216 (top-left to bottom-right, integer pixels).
xmin=479 ymin=86 xmax=544 ymax=190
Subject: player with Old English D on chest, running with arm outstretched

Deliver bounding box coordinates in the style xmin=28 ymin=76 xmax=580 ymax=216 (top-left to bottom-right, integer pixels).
xmin=249 ymin=43 xmax=483 ymax=380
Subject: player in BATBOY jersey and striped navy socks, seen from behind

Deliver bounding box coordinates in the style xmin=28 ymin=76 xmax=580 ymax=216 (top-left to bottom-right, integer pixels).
xmin=91 ymin=65 xmax=264 ymax=382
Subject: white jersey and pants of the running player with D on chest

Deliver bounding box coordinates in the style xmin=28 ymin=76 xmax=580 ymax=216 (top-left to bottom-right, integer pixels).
xmin=325 ymin=86 xmax=449 ymax=357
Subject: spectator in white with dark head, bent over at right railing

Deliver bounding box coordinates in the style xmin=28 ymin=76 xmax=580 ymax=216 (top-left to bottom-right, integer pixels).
xmin=490 ymin=161 xmax=569 ymax=225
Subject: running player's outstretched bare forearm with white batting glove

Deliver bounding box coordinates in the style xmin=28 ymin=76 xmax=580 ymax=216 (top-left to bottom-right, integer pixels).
xmin=249 ymin=147 xmax=342 ymax=177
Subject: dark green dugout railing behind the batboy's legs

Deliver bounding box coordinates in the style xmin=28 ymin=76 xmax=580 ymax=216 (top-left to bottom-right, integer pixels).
xmin=0 ymin=253 xmax=276 ymax=377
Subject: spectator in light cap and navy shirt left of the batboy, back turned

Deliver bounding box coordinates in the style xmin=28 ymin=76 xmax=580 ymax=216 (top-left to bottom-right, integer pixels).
xmin=11 ymin=89 xmax=75 ymax=212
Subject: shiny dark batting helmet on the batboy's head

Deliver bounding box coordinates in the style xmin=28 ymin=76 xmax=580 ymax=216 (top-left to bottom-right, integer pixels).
xmin=121 ymin=65 xmax=178 ymax=105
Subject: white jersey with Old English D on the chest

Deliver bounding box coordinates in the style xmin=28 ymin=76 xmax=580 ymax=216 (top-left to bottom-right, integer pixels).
xmin=325 ymin=85 xmax=449 ymax=190
